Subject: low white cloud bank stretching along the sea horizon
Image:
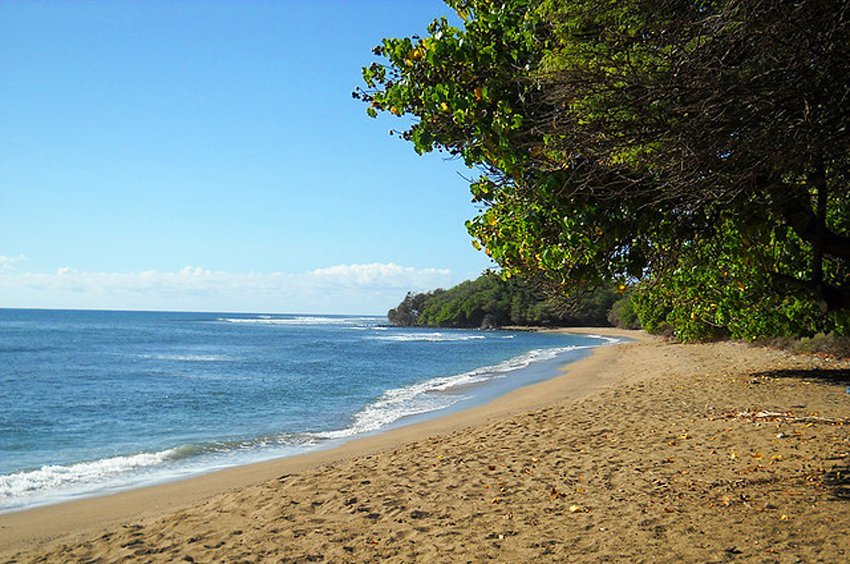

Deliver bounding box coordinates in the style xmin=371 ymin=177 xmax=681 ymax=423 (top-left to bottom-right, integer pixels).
xmin=0 ymin=264 xmax=458 ymax=314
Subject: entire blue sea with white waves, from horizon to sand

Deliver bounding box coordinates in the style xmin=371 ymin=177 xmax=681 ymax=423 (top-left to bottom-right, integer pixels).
xmin=0 ymin=310 xmax=606 ymax=512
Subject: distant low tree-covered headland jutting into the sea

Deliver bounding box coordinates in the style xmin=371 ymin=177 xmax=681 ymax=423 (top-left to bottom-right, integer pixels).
xmin=387 ymin=273 xmax=620 ymax=328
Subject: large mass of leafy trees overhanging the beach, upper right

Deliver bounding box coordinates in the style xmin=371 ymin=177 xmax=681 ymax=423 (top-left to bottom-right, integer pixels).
xmin=354 ymin=0 xmax=850 ymax=341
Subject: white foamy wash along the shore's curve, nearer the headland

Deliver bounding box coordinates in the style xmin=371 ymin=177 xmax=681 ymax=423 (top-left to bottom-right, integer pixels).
xmin=318 ymin=346 xmax=592 ymax=439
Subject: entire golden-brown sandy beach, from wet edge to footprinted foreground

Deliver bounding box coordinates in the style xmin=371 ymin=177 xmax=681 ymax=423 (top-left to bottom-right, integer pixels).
xmin=0 ymin=330 xmax=850 ymax=562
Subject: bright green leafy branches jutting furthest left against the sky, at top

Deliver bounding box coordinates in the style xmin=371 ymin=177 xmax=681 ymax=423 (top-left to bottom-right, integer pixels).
xmin=356 ymin=0 xmax=541 ymax=174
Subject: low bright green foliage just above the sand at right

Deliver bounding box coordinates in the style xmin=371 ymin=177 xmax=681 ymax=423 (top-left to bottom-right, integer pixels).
xmin=632 ymin=224 xmax=850 ymax=341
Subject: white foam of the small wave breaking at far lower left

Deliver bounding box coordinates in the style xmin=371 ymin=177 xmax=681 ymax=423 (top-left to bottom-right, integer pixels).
xmin=0 ymin=449 xmax=176 ymax=502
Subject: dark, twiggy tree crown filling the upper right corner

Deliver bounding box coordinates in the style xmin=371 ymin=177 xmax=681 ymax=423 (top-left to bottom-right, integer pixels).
xmin=536 ymin=0 xmax=850 ymax=304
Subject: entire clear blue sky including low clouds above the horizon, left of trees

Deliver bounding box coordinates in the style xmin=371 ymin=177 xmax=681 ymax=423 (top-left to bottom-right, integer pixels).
xmin=0 ymin=0 xmax=490 ymax=313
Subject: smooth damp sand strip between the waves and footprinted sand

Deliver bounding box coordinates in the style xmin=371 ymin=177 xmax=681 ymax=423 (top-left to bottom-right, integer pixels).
xmin=0 ymin=327 xmax=644 ymax=556
